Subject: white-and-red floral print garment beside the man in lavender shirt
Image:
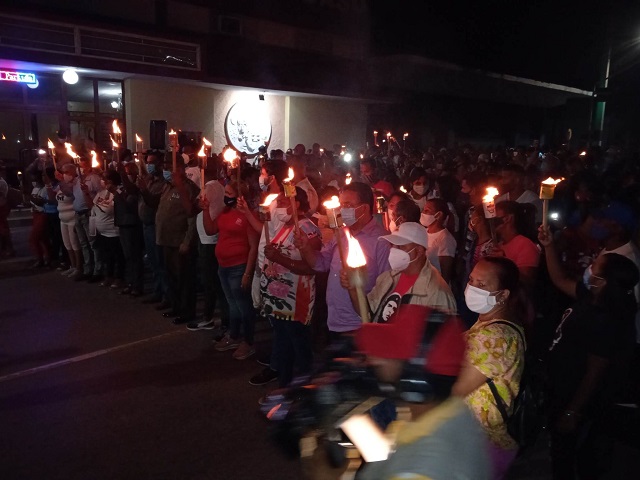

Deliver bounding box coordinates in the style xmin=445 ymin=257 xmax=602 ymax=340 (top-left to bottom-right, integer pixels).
xmin=260 ymin=219 xmax=320 ymax=325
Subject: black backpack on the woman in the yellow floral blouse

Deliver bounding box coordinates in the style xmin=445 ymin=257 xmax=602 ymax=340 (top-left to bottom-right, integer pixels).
xmin=487 ymin=320 xmax=545 ymax=449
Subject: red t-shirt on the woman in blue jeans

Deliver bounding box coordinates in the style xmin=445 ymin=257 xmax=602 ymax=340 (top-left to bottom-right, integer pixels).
xmin=216 ymin=208 xmax=253 ymax=267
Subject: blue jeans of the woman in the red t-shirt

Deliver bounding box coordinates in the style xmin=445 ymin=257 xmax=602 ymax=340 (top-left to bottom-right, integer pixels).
xmin=218 ymin=263 xmax=255 ymax=345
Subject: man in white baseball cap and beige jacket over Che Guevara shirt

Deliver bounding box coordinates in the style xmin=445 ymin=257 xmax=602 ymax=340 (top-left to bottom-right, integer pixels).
xmin=340 ymin=222 xmax=456 ymax=323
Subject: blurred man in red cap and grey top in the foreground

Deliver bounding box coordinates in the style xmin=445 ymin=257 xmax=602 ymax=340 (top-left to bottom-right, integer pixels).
xmin=352 ymin=305 xmax=491 ymax=480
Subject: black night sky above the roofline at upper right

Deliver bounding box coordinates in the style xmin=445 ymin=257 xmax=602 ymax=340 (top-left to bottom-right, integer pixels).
xmin=370 ymin=0 xmax=640 ymax=89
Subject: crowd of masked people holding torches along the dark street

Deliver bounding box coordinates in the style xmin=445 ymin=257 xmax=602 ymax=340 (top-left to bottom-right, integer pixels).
xmin=0 ymin=136 xmax=640 ymax=480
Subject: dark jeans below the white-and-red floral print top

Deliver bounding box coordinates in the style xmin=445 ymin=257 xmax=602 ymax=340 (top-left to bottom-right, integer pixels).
xmin=271 ymin=318 xmax=313 ymax=387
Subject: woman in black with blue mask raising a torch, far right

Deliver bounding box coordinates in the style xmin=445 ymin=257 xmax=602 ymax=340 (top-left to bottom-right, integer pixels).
xmin=538 ymin=227 xmax=639 ymax=479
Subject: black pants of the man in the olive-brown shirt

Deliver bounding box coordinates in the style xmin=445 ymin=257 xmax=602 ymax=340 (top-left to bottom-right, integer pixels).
xmin=162 ymin=246 xmax=197 ymax=318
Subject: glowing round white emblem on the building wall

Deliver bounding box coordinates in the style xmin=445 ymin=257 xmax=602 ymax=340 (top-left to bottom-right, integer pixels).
xmin=224 ymin=100 xmax=271 ymax=155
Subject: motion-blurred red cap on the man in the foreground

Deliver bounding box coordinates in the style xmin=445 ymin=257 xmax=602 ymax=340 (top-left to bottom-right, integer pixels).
xmin=356 ymin=305 xmax=466 ymax=377
